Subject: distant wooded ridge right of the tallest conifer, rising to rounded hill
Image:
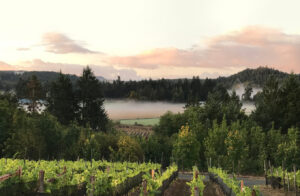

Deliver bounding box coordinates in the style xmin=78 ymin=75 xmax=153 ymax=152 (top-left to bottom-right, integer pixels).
xmin=102 ymin=67 xmax=300 ymax=104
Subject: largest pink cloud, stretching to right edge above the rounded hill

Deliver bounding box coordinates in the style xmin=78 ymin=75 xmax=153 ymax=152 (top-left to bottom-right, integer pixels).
xmin=107 ymin=26 xmax=300 ymax=72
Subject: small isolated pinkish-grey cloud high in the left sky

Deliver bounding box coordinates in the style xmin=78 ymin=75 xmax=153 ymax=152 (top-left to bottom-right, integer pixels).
xmin=42 ymin=32 xmax=100 ymax=54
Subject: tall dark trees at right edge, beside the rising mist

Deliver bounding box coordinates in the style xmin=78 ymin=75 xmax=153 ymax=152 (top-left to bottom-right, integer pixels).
xmin=252 ymin=75 xmax=300 ymax=133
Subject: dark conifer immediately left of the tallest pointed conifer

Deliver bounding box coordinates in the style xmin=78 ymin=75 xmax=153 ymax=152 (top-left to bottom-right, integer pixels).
xmin=48 ymin=73 xmax=77 ymax=125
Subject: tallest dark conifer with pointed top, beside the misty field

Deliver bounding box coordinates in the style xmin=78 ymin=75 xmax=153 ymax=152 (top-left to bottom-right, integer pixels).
xmin=77 ymin=67 xmax=108 ymax=131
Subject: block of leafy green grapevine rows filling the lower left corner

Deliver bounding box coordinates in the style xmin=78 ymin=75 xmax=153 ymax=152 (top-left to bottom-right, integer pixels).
xmin=0 ymin=159 xmax=177 ymax=195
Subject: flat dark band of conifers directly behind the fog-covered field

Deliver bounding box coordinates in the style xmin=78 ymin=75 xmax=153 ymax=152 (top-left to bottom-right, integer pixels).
xmin=102 ymin=77 xmax=216 ymax=103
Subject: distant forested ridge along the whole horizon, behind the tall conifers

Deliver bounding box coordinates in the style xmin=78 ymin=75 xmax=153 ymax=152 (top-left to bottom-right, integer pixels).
xmin=0 ymin=67 xmax=299 ymax=104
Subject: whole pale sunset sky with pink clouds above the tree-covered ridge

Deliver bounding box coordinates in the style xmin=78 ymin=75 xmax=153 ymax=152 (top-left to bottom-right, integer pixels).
xmin=0 ymin=0 xmax=300 ymax=80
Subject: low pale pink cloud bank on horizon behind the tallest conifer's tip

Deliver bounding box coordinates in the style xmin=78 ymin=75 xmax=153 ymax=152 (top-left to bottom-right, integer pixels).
xmin=18 ymin=59 xmax=141 ymax=80
